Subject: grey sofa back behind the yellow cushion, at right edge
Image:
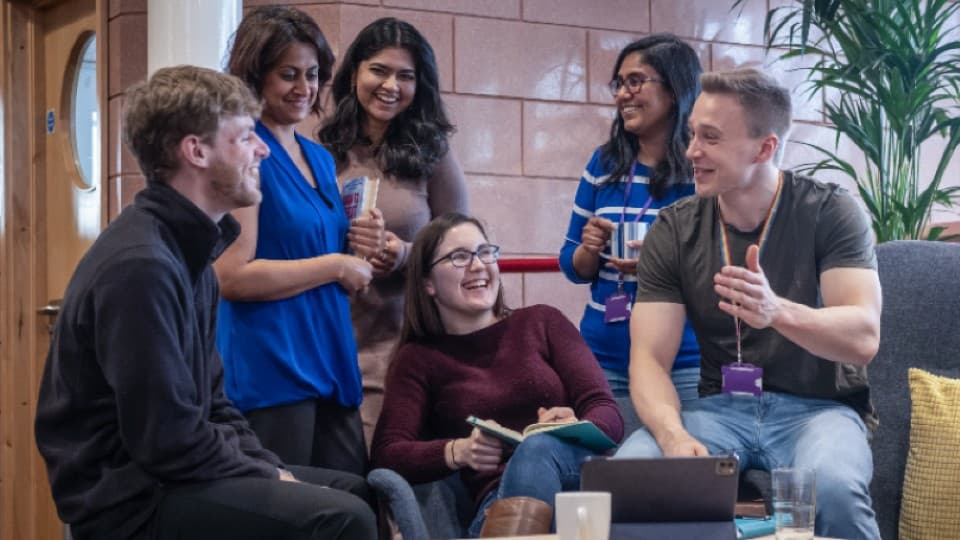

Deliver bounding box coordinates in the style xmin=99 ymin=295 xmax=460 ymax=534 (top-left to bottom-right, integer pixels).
xmin=868 ymin=241 xmax=960 ymax=540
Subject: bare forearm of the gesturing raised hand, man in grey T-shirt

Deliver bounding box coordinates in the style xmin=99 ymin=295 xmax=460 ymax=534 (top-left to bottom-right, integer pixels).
xmin=771 ymin=299 xmax=880 ymax=366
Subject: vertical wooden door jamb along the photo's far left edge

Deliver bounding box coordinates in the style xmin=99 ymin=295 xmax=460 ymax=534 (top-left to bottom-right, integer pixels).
xmin=0 ymin=0 xmax=49 ymax=539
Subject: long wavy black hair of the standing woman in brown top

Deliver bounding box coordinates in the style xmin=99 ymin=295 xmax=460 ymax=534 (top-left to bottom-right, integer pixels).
xmin=318 ymin=17 xmax=453 ymax=179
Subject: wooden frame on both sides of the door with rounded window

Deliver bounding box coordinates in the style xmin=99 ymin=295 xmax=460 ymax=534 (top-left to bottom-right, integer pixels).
xmin=0 ymin=0 xmax=110 ymax=540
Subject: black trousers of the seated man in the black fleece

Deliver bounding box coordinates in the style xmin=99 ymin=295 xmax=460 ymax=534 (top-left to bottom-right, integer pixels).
xmin=149 ymin=466 xmax=377 ymax=540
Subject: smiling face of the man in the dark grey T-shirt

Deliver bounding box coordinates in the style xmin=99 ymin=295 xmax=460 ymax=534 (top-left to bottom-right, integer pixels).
xmin=687 ymin=92 xmax=776 ymax=197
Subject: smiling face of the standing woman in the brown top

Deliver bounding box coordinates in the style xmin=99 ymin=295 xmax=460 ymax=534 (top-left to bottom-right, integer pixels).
xmin=355 ymin=47 xmax=417 ymax=137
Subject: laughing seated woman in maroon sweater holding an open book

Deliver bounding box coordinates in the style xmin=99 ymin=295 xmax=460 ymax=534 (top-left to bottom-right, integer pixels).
xmin=371 ymin=214 xmax=623 ymax=536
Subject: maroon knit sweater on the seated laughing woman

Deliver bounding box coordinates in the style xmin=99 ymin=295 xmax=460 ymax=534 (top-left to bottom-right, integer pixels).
xmin=371 ymin=305 xmax=623 ymax=501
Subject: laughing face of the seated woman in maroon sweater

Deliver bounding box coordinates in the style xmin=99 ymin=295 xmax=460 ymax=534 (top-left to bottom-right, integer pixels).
xmin=424 ymin=223 xmax=500 ymax=334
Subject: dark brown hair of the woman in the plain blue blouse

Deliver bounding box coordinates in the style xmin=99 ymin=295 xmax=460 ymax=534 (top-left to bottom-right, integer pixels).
xmin=227 ymin=6 xmax=333 ymax=114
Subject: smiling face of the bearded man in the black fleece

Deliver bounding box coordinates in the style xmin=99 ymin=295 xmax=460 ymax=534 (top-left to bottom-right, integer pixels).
xmin=207 ymin=116 xmax=270 ymax=212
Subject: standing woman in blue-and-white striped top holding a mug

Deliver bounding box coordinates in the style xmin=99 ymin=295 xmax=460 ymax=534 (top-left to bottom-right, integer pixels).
xmin=560 ymin=34 xmax=702 ymax=412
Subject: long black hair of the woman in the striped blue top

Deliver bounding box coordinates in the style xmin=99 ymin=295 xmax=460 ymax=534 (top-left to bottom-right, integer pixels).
xmin=600 ymin=34 xmax=703 ymax=199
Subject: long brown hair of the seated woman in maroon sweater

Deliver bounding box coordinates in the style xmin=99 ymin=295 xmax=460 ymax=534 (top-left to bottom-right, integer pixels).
xmin=398 ymin=212 xmax=509 ymax=347
